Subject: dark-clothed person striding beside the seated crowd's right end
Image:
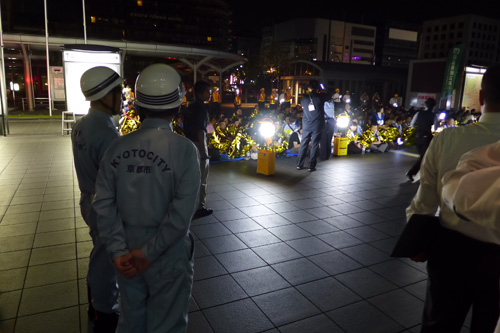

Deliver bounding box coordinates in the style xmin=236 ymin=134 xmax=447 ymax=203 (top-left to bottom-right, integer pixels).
xmin=406 ymin=98 xmax=436 ymax=181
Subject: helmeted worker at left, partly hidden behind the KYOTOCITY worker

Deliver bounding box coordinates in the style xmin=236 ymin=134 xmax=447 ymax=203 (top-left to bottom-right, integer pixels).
xmin=71 ymin=66 xmax=123 ymax=332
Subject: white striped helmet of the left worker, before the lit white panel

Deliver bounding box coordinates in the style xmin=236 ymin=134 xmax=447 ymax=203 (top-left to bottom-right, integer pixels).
xmin=80 ymin=66 xmax=123 ymax=101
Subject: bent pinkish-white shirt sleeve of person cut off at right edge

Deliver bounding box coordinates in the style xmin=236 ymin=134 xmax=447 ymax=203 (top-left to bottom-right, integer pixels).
xmin=442 ymin=142 xmax=500 ymax=230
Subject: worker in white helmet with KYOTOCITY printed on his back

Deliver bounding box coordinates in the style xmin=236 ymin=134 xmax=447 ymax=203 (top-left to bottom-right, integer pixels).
xmin=93 ymin=64 xmax=201 ymax=333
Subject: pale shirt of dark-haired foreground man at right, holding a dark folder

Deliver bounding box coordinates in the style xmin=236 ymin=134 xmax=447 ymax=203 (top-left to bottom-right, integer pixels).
xmin=406 ymin=113 xmax=500 ymax=244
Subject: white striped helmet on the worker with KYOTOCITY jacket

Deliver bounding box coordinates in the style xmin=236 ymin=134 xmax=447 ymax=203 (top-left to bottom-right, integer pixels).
xmin=135 ymin=64 xmax=185 ymax=110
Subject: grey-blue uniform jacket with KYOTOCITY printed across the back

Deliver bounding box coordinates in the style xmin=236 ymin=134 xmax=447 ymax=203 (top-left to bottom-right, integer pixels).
xmin=93 ymin=118 xmax=201 ymax=261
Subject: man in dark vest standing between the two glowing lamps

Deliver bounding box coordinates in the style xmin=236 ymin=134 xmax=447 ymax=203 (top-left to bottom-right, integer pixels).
xmin=297 ymin=80 xmax=325 ymax=172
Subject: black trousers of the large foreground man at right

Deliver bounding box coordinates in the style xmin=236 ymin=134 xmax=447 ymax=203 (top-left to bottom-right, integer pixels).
xmin=422 ymin=226 xmax=500 ymax=333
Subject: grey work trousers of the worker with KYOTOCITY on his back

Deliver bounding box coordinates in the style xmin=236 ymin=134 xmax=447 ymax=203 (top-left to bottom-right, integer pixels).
xmin=116 ymin=228 xmax=194 ymax=333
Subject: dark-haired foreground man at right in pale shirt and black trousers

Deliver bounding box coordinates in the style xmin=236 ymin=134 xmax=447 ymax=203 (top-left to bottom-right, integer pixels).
xmin=406 ymin=65 xmax=500 ymax=333
